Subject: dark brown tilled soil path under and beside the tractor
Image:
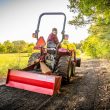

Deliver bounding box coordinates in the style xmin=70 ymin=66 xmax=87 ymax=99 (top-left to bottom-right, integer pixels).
xmin=0 ymin=60 xmax=110 ymax=110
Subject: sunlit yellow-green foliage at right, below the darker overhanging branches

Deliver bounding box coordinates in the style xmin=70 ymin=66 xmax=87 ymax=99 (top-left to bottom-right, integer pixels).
xmin=83 ymin=24 xmax=110 ymax=58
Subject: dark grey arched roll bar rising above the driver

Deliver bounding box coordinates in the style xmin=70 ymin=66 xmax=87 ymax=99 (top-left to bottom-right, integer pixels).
xmin=35 ymin=12 xmax=66 ymax=39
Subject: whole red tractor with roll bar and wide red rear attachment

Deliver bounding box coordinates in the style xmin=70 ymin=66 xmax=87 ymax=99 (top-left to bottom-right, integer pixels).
xmin=6 ymin=12 xmax=81 ymax=95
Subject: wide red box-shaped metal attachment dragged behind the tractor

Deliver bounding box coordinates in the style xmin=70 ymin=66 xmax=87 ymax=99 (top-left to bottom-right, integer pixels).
xmin=6 ymin=70 xmax=61 ymax=95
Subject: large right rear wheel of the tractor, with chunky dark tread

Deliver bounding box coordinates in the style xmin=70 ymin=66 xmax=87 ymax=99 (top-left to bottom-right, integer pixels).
xmin=56 ymin=56 xmax=72 ymax=83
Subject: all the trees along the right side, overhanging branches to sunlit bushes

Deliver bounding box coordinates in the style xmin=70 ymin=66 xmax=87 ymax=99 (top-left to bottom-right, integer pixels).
xmin=68 ymin=0 xmax=110 ymax=59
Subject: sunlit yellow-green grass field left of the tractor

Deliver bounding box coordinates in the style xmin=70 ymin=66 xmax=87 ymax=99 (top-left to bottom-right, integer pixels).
xmin=0 ymin=53 xmax=29 ymax=77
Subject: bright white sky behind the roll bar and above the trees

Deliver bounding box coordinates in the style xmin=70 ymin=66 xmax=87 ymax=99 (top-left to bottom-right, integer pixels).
xmin=0 ymin=0 xmax=89 ymax=43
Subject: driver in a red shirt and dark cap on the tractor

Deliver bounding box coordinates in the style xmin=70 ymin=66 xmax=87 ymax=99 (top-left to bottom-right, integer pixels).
xmin=47 ymin=28 xmax=59 ymax=45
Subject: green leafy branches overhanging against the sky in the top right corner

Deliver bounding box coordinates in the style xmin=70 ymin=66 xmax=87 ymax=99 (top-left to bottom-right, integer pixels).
xmin=68 ymin=0 xmax=110 ymax=26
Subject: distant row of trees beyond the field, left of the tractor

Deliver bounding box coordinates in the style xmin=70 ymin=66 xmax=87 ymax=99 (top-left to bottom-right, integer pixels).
xmin=0 ymin=40 xmax=34 ymax=53
